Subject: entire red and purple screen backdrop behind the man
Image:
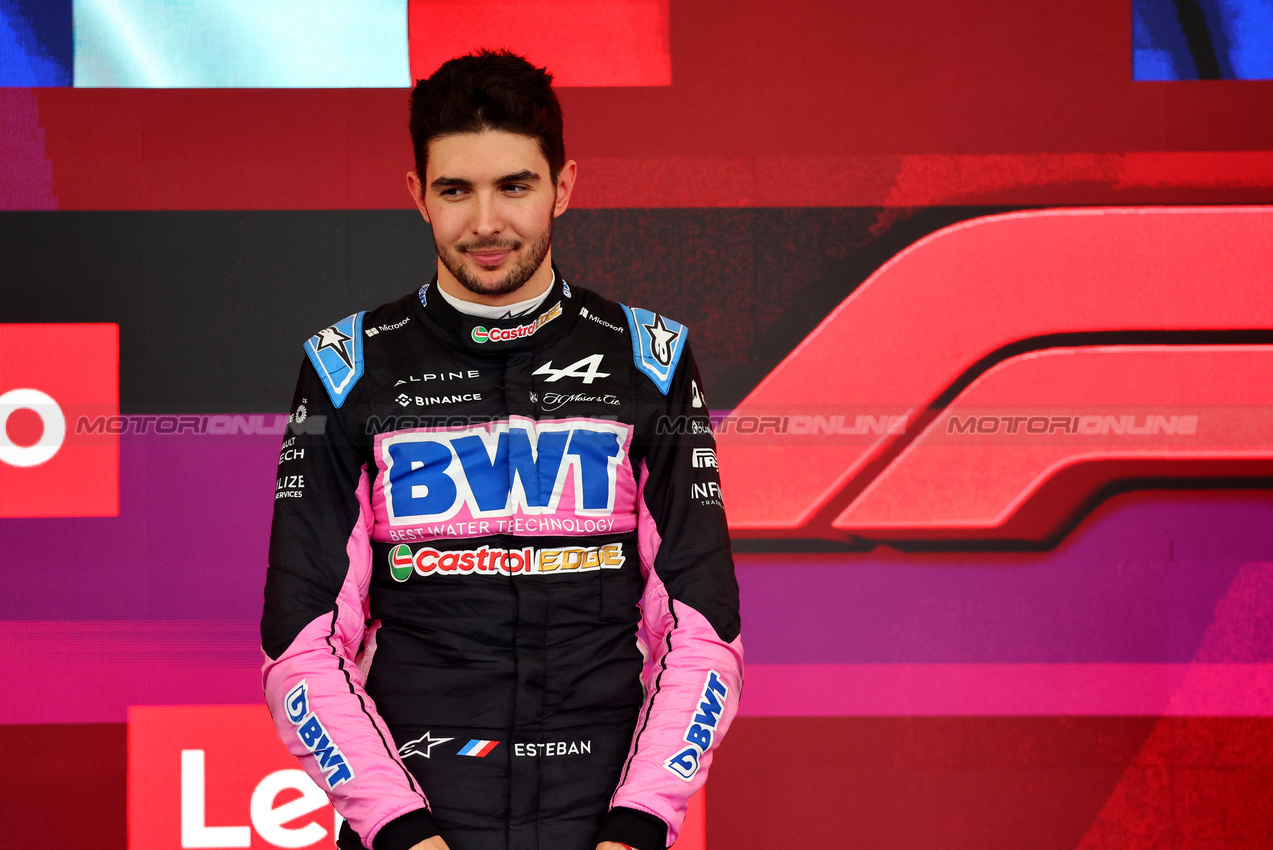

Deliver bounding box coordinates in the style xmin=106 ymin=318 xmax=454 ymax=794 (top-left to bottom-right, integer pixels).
xmin=0 ymin=0 xmax=1273 ymax=850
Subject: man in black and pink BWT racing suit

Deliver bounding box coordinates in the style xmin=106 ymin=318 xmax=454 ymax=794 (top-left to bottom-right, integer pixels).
xmin=261 ymin=52 xmax=742 ymax=850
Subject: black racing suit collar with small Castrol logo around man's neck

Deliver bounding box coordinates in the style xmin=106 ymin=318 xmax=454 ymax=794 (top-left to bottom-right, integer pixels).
xmin=410 ymin=267 xmax=583 ymax=355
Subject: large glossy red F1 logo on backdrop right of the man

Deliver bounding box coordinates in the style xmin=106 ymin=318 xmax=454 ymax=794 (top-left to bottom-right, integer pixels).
xmin=717 ymin=207 xmax=1273 ymax=543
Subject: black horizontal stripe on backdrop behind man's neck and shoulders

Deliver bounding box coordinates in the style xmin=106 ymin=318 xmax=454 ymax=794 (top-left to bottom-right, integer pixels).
xmin=0 ymin=207 xmax=999 ymax=414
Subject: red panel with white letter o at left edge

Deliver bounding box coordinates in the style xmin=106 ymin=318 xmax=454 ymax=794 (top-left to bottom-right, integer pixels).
xmin=0 ymin=324 xmax=120 ymax=517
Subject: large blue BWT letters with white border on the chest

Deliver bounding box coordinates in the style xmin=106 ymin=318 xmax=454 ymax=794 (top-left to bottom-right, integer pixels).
xmin=377 ymin=417 xmax=630 ymax=524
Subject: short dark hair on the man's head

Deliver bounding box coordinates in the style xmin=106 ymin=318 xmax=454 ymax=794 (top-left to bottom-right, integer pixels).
xmin=410 ymin=50 xmax=565 ymax=183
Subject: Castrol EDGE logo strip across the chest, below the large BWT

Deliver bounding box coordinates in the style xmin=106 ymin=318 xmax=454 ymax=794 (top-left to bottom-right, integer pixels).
xmin=390 ymin=543 xmax=625 ymax=582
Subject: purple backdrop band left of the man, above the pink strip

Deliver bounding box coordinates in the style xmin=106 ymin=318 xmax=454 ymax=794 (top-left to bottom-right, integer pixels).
xmin=0 ymin=415 xmax=283 ymax=621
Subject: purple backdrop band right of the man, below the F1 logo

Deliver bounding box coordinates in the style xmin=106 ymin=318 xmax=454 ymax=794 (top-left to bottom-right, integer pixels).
xmin=737 ymin=491 xmax=1273 ymax=664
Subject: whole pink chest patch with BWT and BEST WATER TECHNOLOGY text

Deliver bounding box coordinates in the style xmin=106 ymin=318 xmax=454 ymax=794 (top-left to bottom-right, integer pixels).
xmin=373 ymin=416 xmax=635 ymax=542
